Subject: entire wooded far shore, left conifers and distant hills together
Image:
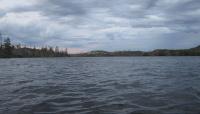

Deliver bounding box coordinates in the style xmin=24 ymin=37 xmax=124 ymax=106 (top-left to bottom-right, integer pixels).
xmin=0 ymin=33 xmax=200 ymax=58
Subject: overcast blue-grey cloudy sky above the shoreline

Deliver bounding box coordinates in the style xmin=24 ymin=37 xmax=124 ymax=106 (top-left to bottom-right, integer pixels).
xmin=0 ymin=0 xmax=200 ymax=53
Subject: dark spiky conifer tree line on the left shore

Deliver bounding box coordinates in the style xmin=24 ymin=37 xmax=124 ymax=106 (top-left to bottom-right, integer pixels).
xmin=0 ymin=38 xmax=69 ymax=58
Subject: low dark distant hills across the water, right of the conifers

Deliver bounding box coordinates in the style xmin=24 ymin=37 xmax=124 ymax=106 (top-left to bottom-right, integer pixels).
xmin=71 ymin=45 xmax=200 ymax=57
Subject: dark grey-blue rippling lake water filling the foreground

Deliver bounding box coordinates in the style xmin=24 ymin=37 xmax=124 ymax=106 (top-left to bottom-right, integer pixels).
xmin=0 ymin=57 xmax=200 ymax=114
